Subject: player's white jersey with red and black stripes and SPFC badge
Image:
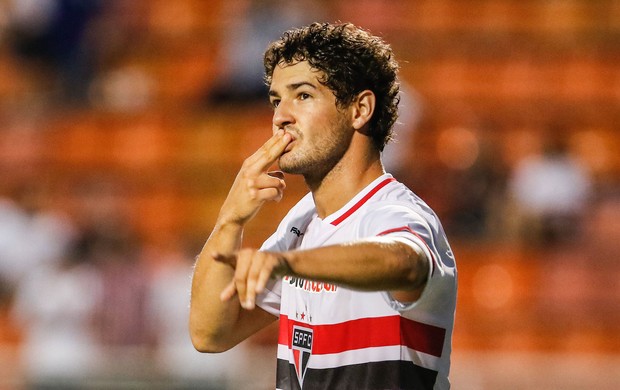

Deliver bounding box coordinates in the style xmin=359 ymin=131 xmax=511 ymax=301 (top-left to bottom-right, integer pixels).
xmin=257 ymin=174 xmax=457 ymax=390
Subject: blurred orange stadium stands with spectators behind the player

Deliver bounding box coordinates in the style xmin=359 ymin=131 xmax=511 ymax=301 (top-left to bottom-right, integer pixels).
xmin=0 ymin=0 xmax=620 ymax=390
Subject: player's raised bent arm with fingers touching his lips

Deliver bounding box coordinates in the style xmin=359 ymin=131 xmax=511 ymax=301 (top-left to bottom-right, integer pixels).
xmin=189 ymin=131 xmax=291 ymax=352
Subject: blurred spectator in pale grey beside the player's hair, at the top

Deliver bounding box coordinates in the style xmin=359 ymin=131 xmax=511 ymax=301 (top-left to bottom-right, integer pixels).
xmin=207 ymin=0 xmax=323 ymax=105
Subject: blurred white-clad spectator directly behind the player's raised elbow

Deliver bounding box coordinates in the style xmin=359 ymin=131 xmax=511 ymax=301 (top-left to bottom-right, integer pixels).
xmin=143 ymin=237 xmax=277 ymax=389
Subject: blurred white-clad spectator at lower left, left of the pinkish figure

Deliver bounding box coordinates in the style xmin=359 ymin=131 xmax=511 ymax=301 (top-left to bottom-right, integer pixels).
xmin=13 ymin=233 xmax=102 ymax=388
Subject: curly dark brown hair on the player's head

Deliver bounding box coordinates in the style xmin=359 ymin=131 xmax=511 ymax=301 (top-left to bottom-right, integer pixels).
xmin=264 ymin=23 xmax=399 ymax=151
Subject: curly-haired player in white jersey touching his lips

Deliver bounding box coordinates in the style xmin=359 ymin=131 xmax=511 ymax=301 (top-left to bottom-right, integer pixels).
xmin=190 ymin=23 xmax=456 ymax=390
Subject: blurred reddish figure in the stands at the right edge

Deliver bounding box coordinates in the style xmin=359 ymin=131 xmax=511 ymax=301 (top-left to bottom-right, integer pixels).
xmin=537 ymin=193 xmax=620 ymax=349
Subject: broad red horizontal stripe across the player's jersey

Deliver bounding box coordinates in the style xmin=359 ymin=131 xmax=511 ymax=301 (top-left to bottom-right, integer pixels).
xmin=278 ymin=314 xmax=446 ymax=357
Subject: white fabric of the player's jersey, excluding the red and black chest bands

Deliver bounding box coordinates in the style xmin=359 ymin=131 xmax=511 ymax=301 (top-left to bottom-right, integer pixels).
xmin=257 ymin=174 xmax=456 ymax=389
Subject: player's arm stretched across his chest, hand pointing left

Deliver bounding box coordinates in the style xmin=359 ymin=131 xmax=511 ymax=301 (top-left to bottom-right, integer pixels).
xmin=217 ymin=236 xmax=430 ymax=309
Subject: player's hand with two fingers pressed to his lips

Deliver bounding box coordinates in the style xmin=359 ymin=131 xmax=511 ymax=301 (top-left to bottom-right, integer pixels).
xmin=218 ymin=130 xmax=292 ymax=226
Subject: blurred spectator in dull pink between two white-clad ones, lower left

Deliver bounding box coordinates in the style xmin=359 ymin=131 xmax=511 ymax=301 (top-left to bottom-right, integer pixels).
xmin=69 ymin=175 xmax=153 ymax=354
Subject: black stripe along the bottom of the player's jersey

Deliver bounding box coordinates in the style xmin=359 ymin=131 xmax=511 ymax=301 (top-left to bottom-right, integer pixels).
xmin=276 ymin=359 xmax=437 ymax=390
